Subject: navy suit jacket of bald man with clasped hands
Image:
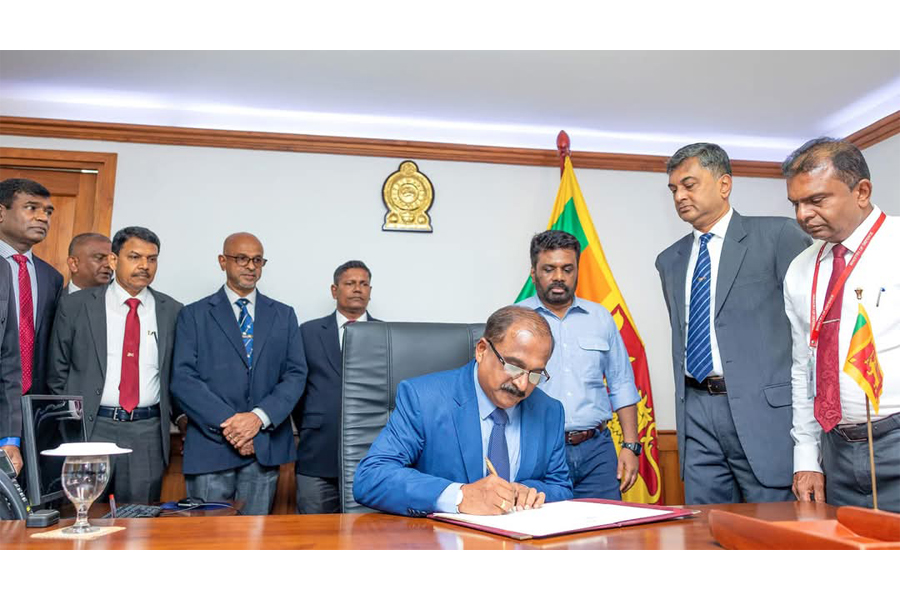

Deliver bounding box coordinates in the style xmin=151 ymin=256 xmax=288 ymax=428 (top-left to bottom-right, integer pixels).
xmin=172 ymin=288 xmax=306 ymax=474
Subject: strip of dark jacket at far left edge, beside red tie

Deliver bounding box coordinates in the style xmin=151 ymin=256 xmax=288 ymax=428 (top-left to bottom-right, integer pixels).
xmin=0 ymin=260 xmax=22 ymax=439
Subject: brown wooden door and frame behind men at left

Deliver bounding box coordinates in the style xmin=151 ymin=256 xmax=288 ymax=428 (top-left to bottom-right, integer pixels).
xmin=0 ymin=148 xmax=116 ymax=282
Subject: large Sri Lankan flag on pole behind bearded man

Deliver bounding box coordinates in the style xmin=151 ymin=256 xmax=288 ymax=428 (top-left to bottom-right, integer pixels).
xmin=516 ymin=157 xmax=662 ymax=504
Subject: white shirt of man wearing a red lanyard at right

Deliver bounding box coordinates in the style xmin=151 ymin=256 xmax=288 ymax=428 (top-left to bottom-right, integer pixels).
xmin=784 ymin=206 xmax=900 ymax=473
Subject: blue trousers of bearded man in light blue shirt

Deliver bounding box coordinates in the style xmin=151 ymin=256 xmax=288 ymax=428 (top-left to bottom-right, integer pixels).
xmin=566 ymin=429 xmax=622 ymax=500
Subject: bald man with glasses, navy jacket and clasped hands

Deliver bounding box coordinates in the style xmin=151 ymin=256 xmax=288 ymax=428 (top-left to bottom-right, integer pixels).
xmin=171 ymin=233 xmax=306 ymax=515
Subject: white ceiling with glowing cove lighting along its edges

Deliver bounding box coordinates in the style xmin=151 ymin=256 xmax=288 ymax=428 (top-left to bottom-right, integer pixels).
xmin=0 ymin=51 xmax=900 ymax=160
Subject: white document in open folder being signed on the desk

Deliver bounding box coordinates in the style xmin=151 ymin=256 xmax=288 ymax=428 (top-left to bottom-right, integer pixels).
xmin=434 ymin=500 xmax=671 ymax=537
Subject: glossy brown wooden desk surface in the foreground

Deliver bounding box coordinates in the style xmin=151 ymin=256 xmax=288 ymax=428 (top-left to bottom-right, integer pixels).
xmin=0 ymin=502 xmax=836 ymax=550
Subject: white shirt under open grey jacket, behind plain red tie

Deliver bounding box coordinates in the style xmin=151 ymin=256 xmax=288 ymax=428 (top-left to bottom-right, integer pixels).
xmin=100 ymin=280 xmax=159 ymax=407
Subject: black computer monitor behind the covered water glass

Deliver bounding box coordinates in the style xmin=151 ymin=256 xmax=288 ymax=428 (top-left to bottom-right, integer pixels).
xmin=19 ymin=395 xmax=86 ymax=507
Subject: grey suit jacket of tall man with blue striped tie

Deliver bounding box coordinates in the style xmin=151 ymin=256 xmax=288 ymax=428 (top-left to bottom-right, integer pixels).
xmin=656 ymin=211 xmax=810 ymax=487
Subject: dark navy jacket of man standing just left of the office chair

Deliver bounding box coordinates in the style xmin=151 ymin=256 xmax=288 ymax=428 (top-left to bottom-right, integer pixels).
xmin=293 ymin=313 xmax=378 ymax=477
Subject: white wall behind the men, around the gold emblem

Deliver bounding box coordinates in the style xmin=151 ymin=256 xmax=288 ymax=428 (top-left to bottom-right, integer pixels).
xmin=0 ymin=136 xmax=900 ymax=429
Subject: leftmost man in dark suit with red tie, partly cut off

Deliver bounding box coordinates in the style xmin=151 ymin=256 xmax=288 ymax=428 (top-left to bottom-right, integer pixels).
xmin=0 ymin=179 xmax=63 ymax=468
